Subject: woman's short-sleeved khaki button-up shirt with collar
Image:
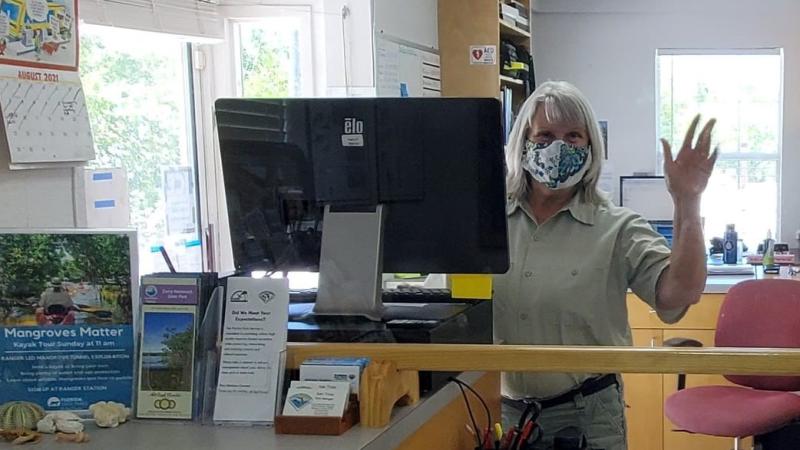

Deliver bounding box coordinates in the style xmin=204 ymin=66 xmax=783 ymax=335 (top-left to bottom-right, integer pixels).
xmin=493 ymin=194 xmax=687 ymax=399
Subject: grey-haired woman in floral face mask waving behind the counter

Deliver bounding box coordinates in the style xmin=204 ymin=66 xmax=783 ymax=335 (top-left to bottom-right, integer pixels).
xmin=494 ymin=82 xmax=717 ymax=450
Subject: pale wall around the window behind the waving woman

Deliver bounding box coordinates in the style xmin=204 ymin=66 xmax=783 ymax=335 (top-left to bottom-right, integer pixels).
xmin=533 ymin=0 xmax=800 ymax=246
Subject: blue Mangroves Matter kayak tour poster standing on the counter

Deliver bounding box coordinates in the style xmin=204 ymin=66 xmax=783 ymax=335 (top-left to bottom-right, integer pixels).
xmin=0 ymin=230 xmax=137 ymax=410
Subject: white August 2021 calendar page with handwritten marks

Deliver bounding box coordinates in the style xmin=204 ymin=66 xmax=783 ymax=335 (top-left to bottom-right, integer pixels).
xmin=0 ymin=66 xmax=94 ymax=165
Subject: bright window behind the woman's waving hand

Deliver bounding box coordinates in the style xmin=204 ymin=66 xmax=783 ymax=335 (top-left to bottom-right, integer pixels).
xmin=656 ymin=49 xmax=783 ymax=251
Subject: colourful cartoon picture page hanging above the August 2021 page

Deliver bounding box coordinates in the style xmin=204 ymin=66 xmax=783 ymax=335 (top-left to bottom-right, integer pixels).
xmin=0 ymin=0 xmax=78 ymax=71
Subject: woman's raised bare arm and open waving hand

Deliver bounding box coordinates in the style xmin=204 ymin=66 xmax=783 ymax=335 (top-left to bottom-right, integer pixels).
xmin=656 ymin=115 xmax=718 ymax=309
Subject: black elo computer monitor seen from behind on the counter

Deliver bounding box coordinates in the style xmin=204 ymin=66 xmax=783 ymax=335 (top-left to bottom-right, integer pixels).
xmin=215 ymin=98 xmax=509 ymax=316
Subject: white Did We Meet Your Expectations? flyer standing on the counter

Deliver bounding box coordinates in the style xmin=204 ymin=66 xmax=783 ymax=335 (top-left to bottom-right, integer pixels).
xmin=214 ymin=278 xmax=289 ymax=423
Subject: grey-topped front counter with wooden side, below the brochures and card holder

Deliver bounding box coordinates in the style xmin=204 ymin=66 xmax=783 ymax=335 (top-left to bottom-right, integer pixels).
xmin=62 ymin=372 xmax=500 ymax=450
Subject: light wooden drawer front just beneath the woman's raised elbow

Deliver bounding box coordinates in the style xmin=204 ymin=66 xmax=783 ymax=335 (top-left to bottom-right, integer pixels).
xmin=627 ymin=294 xmax=725 ymax=330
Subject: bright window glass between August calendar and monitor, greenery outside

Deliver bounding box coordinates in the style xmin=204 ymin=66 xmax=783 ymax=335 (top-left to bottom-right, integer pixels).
xmin=80 ymin=25 xmax=202 ymax=274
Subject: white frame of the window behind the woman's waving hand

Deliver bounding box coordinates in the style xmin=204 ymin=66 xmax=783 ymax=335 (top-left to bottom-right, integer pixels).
xmin=654 ymin=47 xmax=785 ymax=241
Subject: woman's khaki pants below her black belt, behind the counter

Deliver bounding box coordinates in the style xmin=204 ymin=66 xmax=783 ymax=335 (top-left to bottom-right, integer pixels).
xmin=502 ymin=385 xmax=627 ymax=450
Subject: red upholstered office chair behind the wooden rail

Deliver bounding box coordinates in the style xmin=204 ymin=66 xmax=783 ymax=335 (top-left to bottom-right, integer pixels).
xmin=665 ymin=279 xmax=800 ymax=450
